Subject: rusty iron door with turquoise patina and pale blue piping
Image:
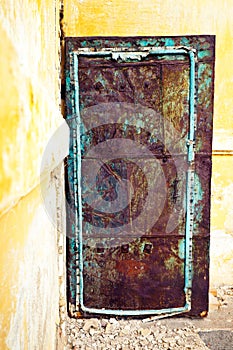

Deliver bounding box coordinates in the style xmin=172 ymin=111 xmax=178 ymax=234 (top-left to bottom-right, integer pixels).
xmin=66 ymin=36 xmax=214 ymax=316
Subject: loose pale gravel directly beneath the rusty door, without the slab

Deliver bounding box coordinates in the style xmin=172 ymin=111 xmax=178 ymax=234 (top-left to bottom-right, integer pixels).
xmin=65 ymin=318 xmax=209 ymax=350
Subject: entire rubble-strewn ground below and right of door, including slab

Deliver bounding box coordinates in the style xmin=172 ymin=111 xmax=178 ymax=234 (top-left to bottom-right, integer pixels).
xmin=65 ymin=287 xmax=233 ymax=350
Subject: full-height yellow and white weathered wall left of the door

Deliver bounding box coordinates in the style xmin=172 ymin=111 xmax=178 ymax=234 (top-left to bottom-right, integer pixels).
xmin=0 ymin=0 xmax=65 ymax=350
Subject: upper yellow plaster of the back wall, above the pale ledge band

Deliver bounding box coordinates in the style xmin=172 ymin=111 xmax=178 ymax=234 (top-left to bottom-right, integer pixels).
xmin=63 ymin=0 xmax=233 ymax=131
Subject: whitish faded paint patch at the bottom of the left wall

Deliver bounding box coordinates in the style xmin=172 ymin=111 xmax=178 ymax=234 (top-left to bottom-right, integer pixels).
xmin=6 ymin=179 xmax=58 ymax=350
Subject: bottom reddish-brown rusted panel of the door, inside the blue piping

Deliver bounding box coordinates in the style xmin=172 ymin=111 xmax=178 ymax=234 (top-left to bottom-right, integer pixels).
xmin=84 ymin=236 xmax=185 ymax=310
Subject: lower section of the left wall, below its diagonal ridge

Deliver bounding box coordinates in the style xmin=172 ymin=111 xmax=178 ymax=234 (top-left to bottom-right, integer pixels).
xmin=0 ymin=179 xmax=59 ymax=350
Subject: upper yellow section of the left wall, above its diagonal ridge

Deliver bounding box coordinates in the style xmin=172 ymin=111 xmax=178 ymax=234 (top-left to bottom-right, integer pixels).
xmin=0 ymin=0 xmax=62 ymax=214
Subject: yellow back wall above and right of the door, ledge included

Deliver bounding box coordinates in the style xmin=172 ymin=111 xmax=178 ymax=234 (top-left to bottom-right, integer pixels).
xmin=63 ymin=0 xmax=233 ymax=288
